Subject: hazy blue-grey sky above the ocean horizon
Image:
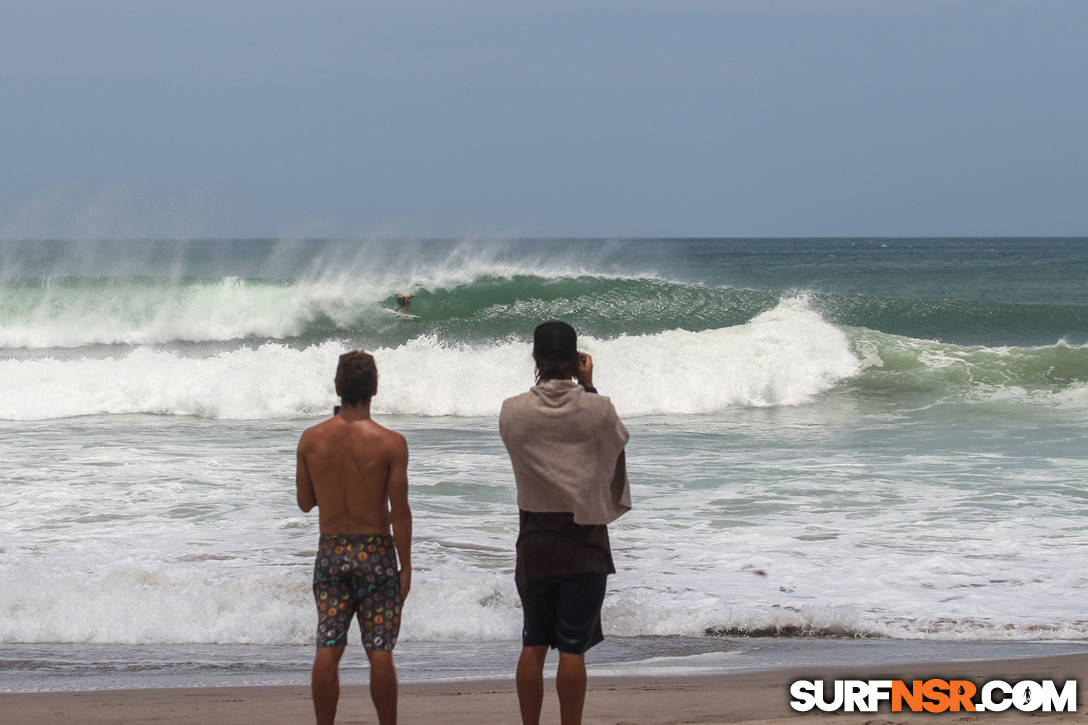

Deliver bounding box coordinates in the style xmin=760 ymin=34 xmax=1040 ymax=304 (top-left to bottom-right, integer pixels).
xmin=0 ymin=0 xmax=1088 ymax=238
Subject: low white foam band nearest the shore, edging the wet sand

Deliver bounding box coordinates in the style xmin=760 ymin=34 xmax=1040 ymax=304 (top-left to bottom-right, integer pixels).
xmin=0 ymin=561 xmax=1088 ymax=644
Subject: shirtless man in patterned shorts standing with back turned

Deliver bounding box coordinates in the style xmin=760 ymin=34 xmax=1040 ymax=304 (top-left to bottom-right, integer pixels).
xmin=295 ymin=351 xmax=411 ymax=725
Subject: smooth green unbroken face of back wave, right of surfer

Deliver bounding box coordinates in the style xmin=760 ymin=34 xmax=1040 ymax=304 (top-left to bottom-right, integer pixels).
xmin=412 ymin=277 xmax=1088 ymax=345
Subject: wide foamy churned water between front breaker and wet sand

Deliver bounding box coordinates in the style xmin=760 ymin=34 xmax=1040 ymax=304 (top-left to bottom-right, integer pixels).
xmin=0 ymin=396 xmax=1088 ymax=644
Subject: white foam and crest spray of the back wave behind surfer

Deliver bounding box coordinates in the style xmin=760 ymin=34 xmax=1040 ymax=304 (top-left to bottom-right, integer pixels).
xmin=0 ymin=255 xmax=657 ymax=349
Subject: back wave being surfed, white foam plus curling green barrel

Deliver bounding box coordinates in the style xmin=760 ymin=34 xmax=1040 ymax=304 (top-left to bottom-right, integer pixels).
xmin=0 ymin=275 xmax=792 ymax=347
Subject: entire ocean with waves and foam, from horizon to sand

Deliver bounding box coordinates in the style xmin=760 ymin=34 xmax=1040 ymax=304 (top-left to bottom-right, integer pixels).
xmin=0 ymin=238 xmax=1088 ymax=691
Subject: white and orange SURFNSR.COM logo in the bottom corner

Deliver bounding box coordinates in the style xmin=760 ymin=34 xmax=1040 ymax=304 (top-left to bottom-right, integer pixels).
xmin=790 ymin=678 xmax=1077 ymax=713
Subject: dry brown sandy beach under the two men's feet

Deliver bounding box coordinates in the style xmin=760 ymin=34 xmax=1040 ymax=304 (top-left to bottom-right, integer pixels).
xmin=0 ymin=654 xmax=1088 ymax=725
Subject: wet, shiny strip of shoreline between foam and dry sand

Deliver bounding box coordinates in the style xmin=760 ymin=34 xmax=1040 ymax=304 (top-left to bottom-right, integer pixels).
xmin=0 ymin=635 xmax=1088 ymax=693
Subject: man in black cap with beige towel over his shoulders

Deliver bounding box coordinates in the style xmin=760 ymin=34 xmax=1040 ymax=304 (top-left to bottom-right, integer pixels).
xmin=498 ymin=320 xmax=631 ymax=725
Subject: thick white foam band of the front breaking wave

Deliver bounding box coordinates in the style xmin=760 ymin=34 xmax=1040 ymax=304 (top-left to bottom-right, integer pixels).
xmin=0 ymin=300 xmax=858 ymax=420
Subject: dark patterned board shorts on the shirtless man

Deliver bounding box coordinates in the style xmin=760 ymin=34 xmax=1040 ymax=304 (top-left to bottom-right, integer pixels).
xmin=313 ymin=533 xmax=401 ymax=652
